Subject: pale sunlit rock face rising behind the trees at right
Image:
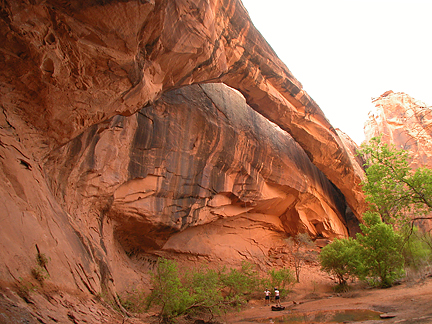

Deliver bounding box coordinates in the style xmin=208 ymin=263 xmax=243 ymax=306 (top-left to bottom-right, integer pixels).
xmin=365 ymin=91 xmax=432 ymax=168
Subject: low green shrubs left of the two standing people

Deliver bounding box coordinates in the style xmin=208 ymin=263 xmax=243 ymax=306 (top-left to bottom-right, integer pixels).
xmin=140 ymin=259 xmax=295 ymax=321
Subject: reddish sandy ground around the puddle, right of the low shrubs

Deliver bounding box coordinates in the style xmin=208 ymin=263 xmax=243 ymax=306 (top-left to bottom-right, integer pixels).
xmin=224 ymin=269 xmax=432 ymax=324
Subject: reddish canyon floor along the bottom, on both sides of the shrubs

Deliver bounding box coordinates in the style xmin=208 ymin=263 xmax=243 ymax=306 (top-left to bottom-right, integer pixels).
xmin=0 ymin=266 xmax=432 ymax=324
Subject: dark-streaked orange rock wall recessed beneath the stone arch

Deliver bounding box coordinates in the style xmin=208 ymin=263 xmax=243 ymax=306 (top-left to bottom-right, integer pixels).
xmin=45 ymin=84 xmax=348 ymax=266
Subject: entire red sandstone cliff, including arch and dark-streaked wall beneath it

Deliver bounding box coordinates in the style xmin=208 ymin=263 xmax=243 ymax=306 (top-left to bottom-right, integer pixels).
xmin=0 ymin=0 xmax=364 ymax=322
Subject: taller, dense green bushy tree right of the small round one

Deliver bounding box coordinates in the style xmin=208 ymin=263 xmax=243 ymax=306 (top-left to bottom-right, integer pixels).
xmin=356 ymin=212 xmax=404 ymax=287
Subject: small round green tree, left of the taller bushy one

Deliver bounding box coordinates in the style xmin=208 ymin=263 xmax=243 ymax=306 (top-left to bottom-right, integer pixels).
xmin=319 ymin=237 xmax=363 ymax=286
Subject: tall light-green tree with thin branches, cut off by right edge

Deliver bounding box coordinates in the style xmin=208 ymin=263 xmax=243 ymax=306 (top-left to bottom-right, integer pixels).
xmin=360 ymin=137 xmax=432 ymax=224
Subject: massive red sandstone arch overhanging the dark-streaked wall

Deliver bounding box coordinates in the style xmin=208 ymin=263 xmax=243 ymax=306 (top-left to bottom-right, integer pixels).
xmin=0 ymin=0 xmax=364 ymax=216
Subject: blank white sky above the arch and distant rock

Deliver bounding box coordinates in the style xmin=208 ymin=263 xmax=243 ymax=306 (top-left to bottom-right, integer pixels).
xmin=242 ymin=0 xmax=432 ymax=144
